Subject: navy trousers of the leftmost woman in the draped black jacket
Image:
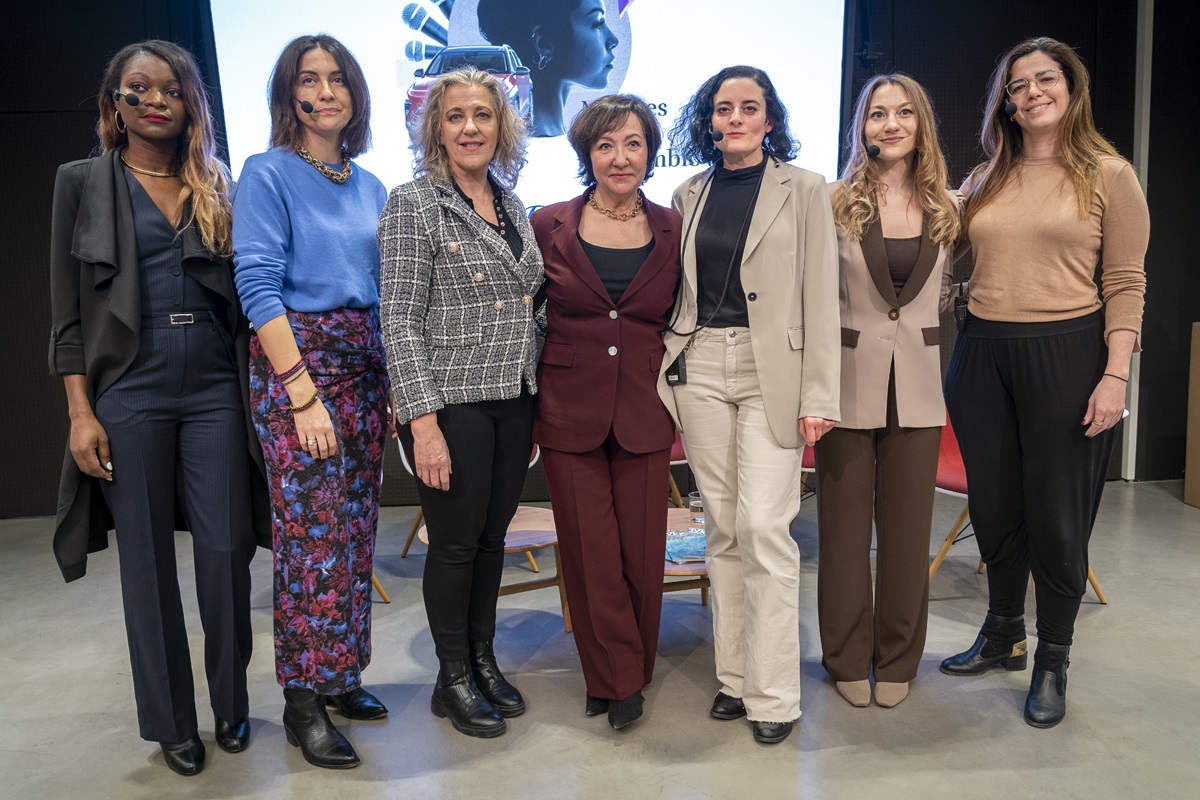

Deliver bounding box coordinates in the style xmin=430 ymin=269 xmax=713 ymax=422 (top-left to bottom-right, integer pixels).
xmin=96 ymin=321 xmax=254 ymax=742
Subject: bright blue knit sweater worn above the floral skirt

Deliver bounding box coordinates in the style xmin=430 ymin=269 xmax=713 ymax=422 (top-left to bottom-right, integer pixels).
xmin=233 ymin=148 xmax=388 ymax=327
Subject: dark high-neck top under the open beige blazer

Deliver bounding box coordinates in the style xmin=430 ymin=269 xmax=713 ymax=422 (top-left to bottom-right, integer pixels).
xmin=696 ymin=157 xmax=767 ymax=327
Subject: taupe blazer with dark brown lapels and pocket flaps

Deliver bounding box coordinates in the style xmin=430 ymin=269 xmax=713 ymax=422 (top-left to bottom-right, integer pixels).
xmin=829 ymin=182 xmax=954 ymax=429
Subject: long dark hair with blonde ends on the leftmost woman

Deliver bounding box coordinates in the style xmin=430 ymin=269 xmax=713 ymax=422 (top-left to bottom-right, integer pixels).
xmin=96 ymin=40 xmax=233 ymax=257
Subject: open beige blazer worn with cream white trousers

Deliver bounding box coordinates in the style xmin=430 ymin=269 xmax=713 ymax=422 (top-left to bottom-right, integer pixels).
xmin=659 ymin=158 xmax=841 ymax=447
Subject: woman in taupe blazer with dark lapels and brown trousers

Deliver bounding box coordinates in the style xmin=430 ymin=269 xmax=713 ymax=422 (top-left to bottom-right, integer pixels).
xmin=816 ymin=74 xmax=960 ymax=708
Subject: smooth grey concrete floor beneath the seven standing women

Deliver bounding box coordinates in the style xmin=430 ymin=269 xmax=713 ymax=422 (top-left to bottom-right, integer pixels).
xmin=0 ymin=482 xmax=1200 ymax=800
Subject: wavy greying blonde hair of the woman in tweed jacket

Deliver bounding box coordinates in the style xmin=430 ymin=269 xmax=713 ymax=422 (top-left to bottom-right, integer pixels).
xmin=413 ymin=67 xmax=526 ymax=188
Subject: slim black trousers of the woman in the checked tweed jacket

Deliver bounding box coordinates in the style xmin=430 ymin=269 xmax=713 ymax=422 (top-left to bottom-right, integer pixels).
xmin=400 ymin=392 xmax=533 ymax=661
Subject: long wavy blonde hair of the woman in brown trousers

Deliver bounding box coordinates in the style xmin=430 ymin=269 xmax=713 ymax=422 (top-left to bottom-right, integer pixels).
xmin=833 ymin=72 xmax=962 ymax=247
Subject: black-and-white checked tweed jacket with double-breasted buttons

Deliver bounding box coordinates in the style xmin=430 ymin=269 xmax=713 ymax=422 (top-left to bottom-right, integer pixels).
xmin=378 ymin=176 xmax=542 ymax=425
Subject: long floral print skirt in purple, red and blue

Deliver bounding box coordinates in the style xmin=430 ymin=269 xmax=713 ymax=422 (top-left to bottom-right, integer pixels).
xmin=250 ymin=308 xmax=389 ymax=694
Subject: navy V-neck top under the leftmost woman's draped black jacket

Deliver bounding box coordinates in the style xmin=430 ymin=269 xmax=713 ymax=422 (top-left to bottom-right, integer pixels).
xmin=125 ymin=172 xmax=221 ymax=324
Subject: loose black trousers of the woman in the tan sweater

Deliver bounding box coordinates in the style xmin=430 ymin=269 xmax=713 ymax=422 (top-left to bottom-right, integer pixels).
xmin=946 ymin=311 xmax=1116 ymax=645
